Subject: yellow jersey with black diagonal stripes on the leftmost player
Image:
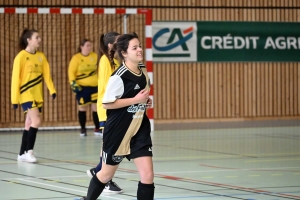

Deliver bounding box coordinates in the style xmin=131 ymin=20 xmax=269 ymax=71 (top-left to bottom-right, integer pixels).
xmin=11 ymin=50 xmax=56 ymax=104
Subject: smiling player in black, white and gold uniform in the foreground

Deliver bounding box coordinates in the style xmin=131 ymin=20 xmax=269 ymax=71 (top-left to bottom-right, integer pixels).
xmin=81 ymin=33 xmax=154 ymax=200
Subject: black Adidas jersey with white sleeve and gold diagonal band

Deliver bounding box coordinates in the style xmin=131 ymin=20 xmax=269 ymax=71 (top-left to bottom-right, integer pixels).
xmin=102 ymin=63 xmax=152 ymax=155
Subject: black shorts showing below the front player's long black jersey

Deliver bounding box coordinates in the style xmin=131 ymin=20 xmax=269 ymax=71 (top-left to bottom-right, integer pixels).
xmin=102 ymin=146 xmax=153 ymax=165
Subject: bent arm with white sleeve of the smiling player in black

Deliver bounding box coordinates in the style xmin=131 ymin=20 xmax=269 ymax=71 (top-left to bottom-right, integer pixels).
xmin=102 ymin=75 xmax=149 ymax=109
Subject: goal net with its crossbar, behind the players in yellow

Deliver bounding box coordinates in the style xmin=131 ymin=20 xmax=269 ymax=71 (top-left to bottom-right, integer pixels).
xmin=0 ymin=8 xmax=153 ymax=130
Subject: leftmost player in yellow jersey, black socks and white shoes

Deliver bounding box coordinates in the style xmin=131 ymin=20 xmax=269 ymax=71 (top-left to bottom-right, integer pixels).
xmin=11 ymin=29 xmax=56 ymax=162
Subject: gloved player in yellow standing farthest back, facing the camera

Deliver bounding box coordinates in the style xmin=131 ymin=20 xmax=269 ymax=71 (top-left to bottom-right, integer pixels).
xmin=68 ymin=39 xmax=102 ymax=136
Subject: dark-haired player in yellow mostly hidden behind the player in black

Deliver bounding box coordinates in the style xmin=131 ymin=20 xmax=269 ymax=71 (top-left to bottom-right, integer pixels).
xmin=87 ymin=31 xmax=122 ymax=193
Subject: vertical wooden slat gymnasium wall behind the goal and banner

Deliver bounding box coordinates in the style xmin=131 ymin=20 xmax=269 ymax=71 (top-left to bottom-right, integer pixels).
xmin=0 ymin=0 xmax=300 ymax=127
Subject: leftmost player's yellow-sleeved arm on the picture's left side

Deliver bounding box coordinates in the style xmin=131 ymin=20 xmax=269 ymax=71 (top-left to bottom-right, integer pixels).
xmin=11 ymin=57 xmax=21 ymax=104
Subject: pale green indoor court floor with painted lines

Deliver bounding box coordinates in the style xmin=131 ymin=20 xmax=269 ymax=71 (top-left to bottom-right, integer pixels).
xmin=0 ymin=122 xmax=300 ymax=200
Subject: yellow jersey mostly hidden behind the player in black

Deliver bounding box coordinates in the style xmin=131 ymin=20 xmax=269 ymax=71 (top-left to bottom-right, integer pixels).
xmin=97 ymin=55 xmax=120 ymax=122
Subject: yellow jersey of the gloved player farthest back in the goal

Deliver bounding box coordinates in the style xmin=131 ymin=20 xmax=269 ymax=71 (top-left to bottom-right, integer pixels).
xmin=68 ymin=52 xmax=98 ymax=87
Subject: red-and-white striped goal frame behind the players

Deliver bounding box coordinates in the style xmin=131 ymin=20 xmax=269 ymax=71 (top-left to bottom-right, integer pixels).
xmin=0 ymin=7 xmax=154 ymax=131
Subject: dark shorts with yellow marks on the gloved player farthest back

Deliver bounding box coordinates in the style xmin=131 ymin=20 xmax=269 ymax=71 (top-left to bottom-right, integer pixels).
xmin=76 ymin=86 xmax=98 ymax=105
